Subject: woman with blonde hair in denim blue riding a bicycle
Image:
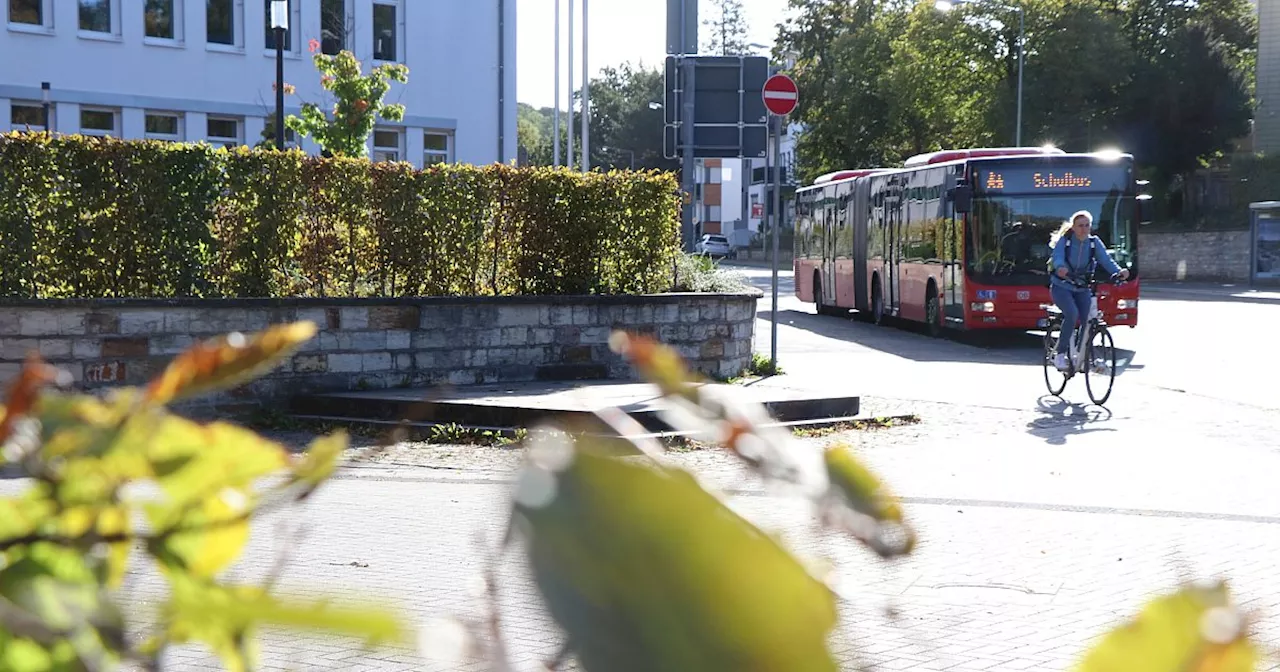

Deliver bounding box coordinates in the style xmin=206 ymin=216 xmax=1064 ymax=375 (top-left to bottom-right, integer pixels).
xmin=1048 ymin=210 xmax=1129 ymax=371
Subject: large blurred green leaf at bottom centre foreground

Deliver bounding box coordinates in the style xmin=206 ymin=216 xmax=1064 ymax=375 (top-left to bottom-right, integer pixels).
xmin=516 ymin=437 xmax=837 ymax=672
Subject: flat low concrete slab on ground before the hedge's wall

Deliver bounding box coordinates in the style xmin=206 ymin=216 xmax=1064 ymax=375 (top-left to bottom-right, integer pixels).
xmin=291 ymin=376 xmax=859 ymax=431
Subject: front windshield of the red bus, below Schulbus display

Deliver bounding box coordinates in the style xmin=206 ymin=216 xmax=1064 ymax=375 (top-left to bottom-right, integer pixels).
xmin=965 ymin=191 xmax=1137 ymax=284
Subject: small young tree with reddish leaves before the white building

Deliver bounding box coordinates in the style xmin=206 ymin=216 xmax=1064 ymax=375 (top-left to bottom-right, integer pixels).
xmin=284 ymin=40 xmax=408 ymax=157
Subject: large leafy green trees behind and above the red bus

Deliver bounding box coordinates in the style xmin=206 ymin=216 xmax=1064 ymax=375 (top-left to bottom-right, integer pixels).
xmin=778 ymin=0 xmax=1257 ymax=188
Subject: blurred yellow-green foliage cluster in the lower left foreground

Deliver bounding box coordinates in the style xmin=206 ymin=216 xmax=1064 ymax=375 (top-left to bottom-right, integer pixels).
xmin=0 ymin=323 xmax=410 ymax=672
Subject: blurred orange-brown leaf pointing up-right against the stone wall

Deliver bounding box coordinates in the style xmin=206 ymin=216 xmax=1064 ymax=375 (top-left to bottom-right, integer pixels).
xmin=146 ymin=321 xmax=317 ymax=404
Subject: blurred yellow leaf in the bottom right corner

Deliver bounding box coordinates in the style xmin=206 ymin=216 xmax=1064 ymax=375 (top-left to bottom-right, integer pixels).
xmin=1076 ymin=581 xmax=1258 ymax=672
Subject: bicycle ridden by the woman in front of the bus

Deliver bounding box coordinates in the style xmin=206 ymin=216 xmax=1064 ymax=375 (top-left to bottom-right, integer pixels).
xmin=1041 ymin=274 xmax=1123 ymax=406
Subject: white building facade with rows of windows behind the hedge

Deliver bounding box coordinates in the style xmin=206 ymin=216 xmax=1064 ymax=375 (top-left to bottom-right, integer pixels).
xmin=0 ymin=0 xmax=517 ymax=166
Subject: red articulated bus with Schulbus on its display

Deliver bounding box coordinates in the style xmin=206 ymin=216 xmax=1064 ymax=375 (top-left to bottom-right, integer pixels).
xmin=792 ymin=147 xmax=1139 ymax=334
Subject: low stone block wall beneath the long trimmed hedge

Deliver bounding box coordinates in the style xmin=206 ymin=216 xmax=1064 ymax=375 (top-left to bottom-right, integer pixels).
xmin=0 ymin=294 xmax=758 ymax=406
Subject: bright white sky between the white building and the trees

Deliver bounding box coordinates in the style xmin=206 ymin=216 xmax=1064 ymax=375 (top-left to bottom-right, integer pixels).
xmin=516 ymin=0 xmax=787 ymax=109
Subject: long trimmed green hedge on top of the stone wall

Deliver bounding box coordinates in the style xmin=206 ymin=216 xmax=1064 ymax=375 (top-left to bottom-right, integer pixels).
xmin=0 ymin=133 xmax=680 ymax=298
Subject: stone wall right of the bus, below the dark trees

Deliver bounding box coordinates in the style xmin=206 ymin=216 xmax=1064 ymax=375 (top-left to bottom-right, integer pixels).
xmin=1138 ymin=230 xmax=1251 ymax=283
